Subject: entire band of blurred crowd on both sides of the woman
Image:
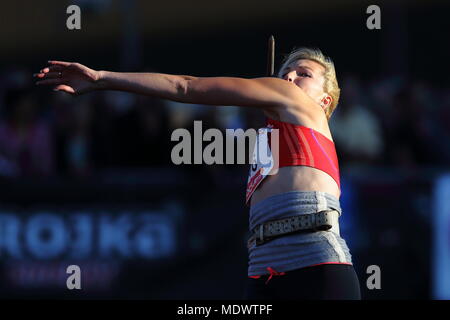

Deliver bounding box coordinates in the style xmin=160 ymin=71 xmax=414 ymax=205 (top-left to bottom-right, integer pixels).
xmin=0 ymin=67 xmax=450 ymax=178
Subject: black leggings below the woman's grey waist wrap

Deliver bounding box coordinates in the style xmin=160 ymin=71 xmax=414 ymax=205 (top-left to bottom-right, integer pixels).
xmin=245 ymin=264 xmax=361 ymax=300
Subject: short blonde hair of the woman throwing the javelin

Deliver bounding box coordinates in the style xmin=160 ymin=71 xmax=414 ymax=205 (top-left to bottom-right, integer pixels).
xmin=277 ymin=48 xmax=341 ymax=121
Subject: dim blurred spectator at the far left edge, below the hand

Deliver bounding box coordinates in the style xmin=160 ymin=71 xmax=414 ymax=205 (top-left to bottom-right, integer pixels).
xmin=0 ymin=87 xmax=55 ymax=177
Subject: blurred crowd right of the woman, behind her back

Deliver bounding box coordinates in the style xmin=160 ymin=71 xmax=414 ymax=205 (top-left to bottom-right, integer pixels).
xmin=330 ymin=75 xmax=450 ymax=170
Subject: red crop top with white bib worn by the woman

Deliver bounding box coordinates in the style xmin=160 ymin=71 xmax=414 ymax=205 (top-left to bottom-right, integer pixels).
xmin=245 ymin=118 xmax=341 ymax=204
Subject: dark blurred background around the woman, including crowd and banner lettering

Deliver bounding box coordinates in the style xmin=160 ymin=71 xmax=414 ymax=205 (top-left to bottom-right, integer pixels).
xmin=0 ymin=0 xmax=450 ymax=299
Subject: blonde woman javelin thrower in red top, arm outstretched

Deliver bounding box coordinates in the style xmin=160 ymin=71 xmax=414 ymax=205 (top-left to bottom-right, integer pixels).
xmin=34 ymin=48 xmax=361 ymax=300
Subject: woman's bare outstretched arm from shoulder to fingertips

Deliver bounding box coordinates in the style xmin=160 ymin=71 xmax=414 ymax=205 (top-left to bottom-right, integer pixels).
xmin=35 ymin=61 xmax=320 ymax=115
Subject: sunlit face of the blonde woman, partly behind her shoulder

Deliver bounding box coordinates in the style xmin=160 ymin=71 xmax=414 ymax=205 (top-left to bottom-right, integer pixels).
xmin=282 ymin=59 xmax=332 ymax=108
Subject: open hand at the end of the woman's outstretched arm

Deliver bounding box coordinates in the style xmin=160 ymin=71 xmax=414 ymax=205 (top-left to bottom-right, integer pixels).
xmin=33 ymin=61 xmax=100 ymax=95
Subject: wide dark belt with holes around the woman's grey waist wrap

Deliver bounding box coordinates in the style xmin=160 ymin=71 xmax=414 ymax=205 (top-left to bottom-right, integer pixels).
xmin=247 ymin=210 xmax=339 ymax=248
